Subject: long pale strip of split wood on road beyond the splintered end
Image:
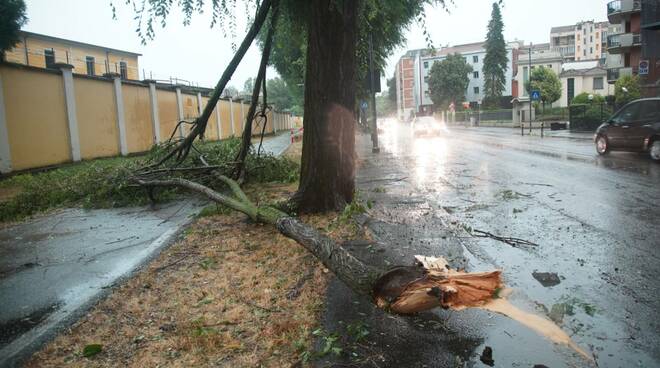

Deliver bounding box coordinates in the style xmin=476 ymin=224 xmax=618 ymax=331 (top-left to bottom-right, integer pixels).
xmin=478 ymin=298 xmax=593 ymax=361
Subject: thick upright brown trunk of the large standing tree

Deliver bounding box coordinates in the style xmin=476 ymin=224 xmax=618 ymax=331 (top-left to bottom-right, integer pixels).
xmin=292 ymin=0 xmax=358 ymax=212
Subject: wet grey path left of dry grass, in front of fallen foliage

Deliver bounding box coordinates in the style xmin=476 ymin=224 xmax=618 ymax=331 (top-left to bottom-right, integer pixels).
xmin=0 ymin=201 xmax=203 ymax=367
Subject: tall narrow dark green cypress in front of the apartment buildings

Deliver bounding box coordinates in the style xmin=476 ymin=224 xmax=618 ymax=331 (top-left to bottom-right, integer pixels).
xmin=483 ymin=3 xmax=509 ymax=106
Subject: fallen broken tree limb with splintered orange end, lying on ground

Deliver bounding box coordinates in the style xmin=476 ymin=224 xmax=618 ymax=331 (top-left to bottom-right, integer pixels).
xmin=134 ymin=174 xmax=502 ymax=314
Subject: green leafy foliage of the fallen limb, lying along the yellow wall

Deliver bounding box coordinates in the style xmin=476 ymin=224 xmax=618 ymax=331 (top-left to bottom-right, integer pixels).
xmin=0 ymin=138 xmax=299 ymax=222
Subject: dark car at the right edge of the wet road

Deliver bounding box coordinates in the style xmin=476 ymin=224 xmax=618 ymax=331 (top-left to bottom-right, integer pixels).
xmin=594 ymin=98 xmax=660 ymax=161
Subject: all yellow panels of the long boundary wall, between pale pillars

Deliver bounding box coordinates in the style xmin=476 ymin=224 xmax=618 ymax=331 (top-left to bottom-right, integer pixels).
xmin=0 ymin=64 xmax=294 ymax=170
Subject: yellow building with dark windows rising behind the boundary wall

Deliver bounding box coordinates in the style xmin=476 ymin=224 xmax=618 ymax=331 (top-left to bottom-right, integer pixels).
xmin=5 ymin=31 xmax=141 ymax=80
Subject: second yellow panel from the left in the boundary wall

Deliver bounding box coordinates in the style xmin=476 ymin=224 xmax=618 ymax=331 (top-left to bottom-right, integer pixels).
xmin=74 ymin=77 xmax=119 ymax=159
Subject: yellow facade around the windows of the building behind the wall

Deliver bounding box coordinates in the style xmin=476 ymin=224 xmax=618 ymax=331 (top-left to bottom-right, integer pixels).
xmin=6 ymin=37 xmax=140 ymax=79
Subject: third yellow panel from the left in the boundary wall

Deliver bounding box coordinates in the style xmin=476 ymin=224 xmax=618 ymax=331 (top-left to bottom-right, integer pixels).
xmin=122 ymin=84 xmax=154 ymax=153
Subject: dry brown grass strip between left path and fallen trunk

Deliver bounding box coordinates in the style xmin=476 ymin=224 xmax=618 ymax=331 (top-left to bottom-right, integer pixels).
xmin=26 ymin=185 xmax=360 ymax=367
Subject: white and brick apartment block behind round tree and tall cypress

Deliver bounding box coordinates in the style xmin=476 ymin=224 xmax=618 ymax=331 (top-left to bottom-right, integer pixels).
xmin=395 ymin=42 xmax=518 ymax=120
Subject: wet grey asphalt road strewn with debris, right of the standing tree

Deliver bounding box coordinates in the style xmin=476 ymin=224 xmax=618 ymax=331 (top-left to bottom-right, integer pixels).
xmin=325 ymin=124 xmax=660 ymax=367
